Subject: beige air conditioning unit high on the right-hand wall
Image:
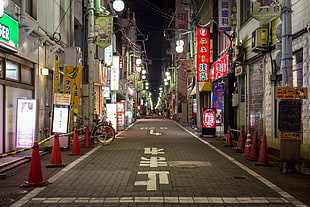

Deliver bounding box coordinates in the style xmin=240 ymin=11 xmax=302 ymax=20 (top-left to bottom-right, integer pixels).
xmin=252 ymin=28 xmax=268 ymax=50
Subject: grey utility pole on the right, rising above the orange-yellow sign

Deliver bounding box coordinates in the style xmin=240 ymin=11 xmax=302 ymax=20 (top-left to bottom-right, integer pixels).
xmin=281 ymin=0 xmax=293 ymax=87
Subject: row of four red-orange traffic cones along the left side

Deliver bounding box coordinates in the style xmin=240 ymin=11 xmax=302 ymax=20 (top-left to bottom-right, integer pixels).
xmin=20 ymin=126 xmax=91 ymax=187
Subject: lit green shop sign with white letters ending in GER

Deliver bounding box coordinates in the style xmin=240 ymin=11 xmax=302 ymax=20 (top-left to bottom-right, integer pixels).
xmin=0 ymin=13 xmax=18 ymax=52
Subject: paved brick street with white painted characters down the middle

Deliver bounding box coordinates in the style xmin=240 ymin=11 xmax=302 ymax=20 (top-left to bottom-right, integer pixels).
xmin=0 ymin=119 xmax=310 ymax=207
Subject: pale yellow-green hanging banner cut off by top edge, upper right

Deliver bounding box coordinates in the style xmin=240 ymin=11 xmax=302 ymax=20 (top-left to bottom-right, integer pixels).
xmin=250 ymin=0 xmax=282 ymax=24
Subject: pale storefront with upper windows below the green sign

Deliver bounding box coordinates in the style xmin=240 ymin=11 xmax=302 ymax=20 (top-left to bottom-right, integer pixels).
xmin=0 ymin=50 xmax=34 ymax=153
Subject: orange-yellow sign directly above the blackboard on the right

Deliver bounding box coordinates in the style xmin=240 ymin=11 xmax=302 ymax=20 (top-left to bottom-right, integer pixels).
xmin=276 ymin=87 xmax=308 ymax=99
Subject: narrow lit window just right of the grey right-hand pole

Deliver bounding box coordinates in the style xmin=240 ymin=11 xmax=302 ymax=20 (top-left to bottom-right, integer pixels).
xmin=293 ymin=50 xmax=303 ymax=87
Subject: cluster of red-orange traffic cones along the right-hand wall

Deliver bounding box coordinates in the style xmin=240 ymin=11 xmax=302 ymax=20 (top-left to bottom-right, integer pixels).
xmin=224 ymin=126 xmax=269 ymax=166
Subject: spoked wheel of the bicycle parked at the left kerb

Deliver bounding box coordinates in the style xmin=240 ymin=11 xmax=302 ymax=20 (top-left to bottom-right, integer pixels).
xmin=93 ymin=124 xmax=115 ymax=145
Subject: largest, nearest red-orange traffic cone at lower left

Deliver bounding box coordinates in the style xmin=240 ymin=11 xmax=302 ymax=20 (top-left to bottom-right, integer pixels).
xmin=20 ymin=142 xmax=49 ymax=187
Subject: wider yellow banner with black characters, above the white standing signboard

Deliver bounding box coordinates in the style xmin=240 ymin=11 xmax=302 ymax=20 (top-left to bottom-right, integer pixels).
xmin=64 ymin=66 xmax=82 ymax=113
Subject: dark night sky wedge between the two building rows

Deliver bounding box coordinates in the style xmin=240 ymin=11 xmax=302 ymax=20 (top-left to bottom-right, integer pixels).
xmin=128 ymin=0 xmax=170 ymax=101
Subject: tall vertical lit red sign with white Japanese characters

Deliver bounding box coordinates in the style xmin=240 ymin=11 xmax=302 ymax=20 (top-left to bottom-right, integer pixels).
xmin=197 ymin=27 xmax=210 ymax=81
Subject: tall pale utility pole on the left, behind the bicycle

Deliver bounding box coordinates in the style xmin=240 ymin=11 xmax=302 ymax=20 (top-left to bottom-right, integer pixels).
xmin=87 ymin=0 xmax=95 ymax=128
